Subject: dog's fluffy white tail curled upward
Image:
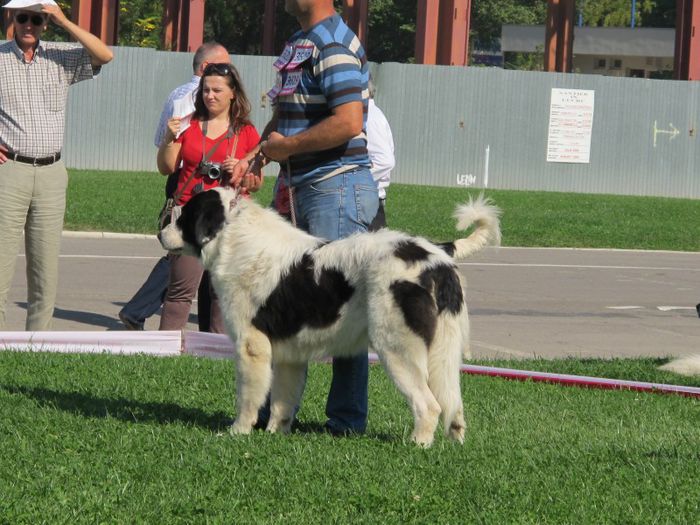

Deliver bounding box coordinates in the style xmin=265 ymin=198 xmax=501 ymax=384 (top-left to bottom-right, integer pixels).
xmin=452 ymin=193 xmax=501 ymax=259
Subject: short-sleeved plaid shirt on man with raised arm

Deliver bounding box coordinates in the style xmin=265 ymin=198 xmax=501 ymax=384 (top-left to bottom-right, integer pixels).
xmin=0 ymin=39 xmax=99 ymax=157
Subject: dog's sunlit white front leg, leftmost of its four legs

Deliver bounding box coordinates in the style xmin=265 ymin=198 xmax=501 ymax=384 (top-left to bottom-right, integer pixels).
xmin=231 ymin=327 xmax=272 ymax=434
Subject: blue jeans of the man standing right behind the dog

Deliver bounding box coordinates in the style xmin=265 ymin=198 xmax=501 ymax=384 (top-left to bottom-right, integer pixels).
xmin=294 ymin=168 xmax=379 ymax=433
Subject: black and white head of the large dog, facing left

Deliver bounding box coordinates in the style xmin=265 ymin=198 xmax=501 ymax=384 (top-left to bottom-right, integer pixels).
xmin=158 ymin=188 xmax=240 ymax=257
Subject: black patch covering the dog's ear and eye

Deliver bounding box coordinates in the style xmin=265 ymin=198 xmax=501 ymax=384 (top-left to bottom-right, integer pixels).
xmin=177 ymin=191 xmax=226 ymax=255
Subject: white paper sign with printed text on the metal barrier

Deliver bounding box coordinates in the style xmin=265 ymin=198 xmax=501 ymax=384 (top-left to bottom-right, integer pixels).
xmin=547 ymin=88 xmax=595 ymax=163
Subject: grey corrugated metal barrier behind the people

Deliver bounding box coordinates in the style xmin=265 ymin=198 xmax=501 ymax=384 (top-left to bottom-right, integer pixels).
xmin=64 ymin=47 xmax=700 ymax=198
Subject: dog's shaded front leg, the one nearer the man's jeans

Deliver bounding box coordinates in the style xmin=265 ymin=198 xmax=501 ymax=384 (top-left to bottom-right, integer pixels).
xmin=267 ymin=363 xmax=306 ymax=433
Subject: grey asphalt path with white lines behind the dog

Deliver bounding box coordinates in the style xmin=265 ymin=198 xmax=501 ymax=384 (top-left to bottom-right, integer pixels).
xmin=6 ymin=233 xmax=700 ymax=358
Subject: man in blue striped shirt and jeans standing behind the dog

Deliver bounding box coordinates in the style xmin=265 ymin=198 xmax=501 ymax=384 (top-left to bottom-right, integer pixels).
xmin=232 ymin=0 xmax=379 ymax=435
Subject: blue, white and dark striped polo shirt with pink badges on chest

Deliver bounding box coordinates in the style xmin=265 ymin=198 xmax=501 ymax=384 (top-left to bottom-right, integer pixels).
xmin=268 ymin=14 xmax=371 ymax=186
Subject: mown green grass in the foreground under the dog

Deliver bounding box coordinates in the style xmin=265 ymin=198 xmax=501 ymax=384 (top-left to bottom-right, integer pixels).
xmin=0 ymin=352 xmax=700 ymax=524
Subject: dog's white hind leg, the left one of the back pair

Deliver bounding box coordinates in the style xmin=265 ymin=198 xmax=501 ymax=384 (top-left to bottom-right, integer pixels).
xmin=377 ymin=339 xmax=440 ymax=448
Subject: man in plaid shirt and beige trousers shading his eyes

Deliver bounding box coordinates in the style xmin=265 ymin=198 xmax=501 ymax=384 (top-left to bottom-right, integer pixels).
xmin=0 ymin=2 xmax=113 ymax=331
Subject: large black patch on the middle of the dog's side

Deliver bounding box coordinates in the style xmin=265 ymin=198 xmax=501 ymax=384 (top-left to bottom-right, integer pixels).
xmin=253 ymin=253 xmax=355 ymax=339
